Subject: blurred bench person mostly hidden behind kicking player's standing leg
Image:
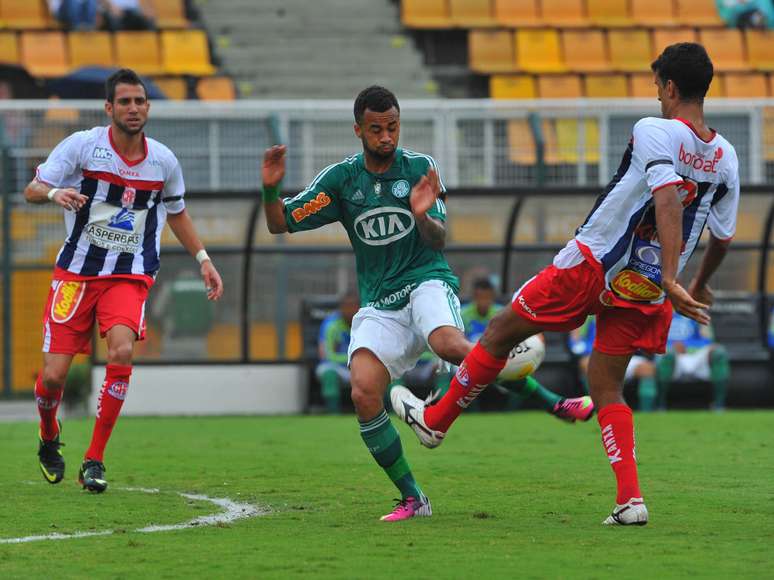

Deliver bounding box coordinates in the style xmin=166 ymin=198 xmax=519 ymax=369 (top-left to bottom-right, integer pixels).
xmin=569 ymin=316 xmax=658 ymax=411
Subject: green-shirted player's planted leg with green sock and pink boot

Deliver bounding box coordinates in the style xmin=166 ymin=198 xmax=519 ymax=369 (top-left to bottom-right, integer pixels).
xmin=350 ymin=348 xmax=432 ymax=521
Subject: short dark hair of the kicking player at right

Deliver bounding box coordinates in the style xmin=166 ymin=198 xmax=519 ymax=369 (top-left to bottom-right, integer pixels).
xmin=650 ymin=42 xmax=714 ymax=102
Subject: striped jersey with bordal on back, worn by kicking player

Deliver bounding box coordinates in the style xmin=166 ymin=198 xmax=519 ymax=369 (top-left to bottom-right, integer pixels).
xmin=554 ymin=117 xmax=739 ymax=304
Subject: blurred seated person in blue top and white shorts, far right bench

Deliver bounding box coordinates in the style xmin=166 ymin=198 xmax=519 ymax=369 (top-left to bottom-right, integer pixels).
xmin=657 ymin=312 xmax=731 ymax=411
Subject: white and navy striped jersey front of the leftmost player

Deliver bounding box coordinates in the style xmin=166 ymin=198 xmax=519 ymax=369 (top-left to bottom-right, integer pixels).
xmin=36 ymin=127 xmax=185 ymax=278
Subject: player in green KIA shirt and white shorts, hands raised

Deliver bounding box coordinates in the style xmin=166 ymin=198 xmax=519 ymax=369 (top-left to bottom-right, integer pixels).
xmin=262 ymin=86 xmax=473 ymax=521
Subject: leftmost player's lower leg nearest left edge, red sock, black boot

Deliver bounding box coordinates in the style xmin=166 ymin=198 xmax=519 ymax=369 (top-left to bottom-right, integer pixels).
xmin=35 ymin=353 xmax=73 ymax=483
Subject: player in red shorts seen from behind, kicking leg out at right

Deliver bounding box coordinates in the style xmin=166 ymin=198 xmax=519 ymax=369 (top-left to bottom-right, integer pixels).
xmin=398 ymin=43 xmax=739 ymax=525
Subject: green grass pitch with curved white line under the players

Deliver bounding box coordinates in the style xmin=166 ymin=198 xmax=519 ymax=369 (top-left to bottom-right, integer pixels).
xmin=0 ymin=412 xmax=774 ymax=579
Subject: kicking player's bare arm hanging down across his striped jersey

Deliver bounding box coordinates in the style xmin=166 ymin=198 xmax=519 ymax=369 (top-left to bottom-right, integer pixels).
xmin=653 ymin=185 xmax=709 ymax=324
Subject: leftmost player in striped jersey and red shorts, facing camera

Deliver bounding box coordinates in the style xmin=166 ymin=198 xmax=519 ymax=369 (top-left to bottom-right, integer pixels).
xmin=24 ymin=69 xmax=223 ymax=492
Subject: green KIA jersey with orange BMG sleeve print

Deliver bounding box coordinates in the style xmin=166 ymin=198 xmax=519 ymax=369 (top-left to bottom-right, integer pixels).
xmin=285 ymin=149 xmax=459 ymax=310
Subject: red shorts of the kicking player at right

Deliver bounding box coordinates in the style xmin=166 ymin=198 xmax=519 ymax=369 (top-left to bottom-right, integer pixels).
xmin=511 ymin=258 xmax=672 ymax=355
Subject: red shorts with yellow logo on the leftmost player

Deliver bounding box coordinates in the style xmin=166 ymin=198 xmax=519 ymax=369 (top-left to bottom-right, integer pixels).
xmin=43 ymin=278 xmax=148 ymax=354
